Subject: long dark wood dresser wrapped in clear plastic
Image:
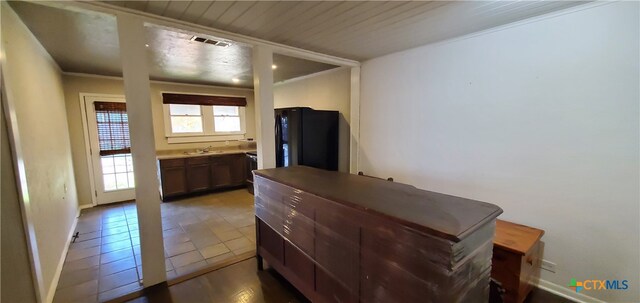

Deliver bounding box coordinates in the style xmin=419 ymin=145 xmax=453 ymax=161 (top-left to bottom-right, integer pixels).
xmin=254 ymin=166 xmax=502 ymax=303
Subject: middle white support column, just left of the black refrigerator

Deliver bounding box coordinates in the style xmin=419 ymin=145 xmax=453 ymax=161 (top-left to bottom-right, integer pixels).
xmin=253 ymin=46 xmax=276 ymax=169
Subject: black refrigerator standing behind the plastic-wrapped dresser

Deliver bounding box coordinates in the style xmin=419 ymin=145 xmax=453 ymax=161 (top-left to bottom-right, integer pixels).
xmin=275 ymin=107 xmax=339 ymax=170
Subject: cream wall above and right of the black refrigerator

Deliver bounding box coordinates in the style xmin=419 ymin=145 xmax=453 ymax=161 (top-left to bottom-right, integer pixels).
xmin=273 ymin=68 xmax=351 ymax=172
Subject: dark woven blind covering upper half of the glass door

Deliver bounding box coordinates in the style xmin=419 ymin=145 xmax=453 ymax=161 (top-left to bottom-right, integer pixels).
xmin=94 ymin=102 xmax=131 ymax=156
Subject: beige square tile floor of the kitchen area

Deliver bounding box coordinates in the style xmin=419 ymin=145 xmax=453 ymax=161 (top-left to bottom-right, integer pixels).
xmin=54 ymin=189 xmax=256 ymax=302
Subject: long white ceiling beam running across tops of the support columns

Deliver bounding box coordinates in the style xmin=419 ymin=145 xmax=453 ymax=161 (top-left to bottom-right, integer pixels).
xmin=37 ymin=1 xmax=360 ymax=67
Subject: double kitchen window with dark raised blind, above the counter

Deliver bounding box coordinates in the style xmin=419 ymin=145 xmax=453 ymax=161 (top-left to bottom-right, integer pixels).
xmin=162 ymin=93 xmax=246 ymax=143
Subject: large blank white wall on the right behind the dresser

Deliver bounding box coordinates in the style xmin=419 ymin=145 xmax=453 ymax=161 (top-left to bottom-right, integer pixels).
xmin=360 ymin=2 xmax=640 ymax=302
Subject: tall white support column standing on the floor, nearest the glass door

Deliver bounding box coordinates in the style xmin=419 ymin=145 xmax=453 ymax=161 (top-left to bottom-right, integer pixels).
xmin=118 ymin=15 xmax=167 ymax=287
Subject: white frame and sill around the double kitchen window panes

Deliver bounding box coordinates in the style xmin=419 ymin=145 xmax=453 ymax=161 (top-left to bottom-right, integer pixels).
xmin=162 ymin=104 xmax=247 ymax=144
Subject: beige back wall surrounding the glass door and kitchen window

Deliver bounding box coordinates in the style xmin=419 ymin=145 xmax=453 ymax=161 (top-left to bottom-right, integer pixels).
xmin=63 ymin=75 xmax=255 ymax=205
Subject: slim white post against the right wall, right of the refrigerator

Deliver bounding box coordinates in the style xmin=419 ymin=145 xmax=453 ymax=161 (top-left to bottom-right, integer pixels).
xmin=349 ymin=67 xmax=360 ymax=174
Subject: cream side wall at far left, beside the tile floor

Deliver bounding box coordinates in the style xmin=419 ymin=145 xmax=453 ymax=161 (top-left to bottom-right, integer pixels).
xmin=1 ymin=3 xmax=78 ymax=300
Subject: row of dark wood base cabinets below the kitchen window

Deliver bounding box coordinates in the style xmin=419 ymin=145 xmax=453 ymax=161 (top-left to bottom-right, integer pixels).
xmin=158 ymin=154 xmax=246 ymax=201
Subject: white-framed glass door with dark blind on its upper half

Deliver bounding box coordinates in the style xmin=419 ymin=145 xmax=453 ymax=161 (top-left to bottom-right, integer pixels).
xmin=84 ymin=96 xmax=135 ymax=204
